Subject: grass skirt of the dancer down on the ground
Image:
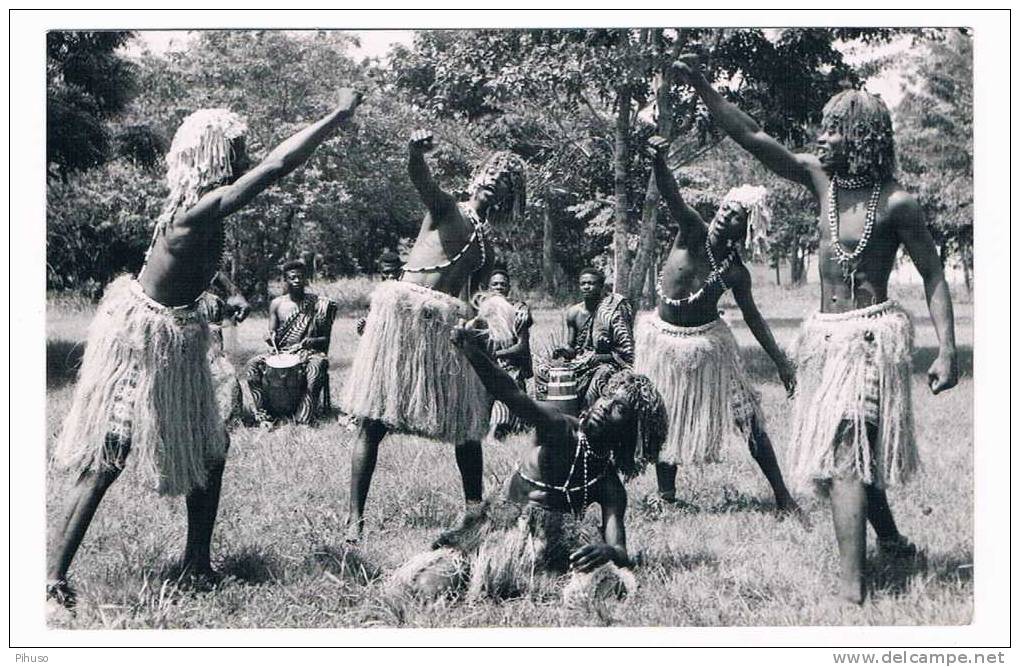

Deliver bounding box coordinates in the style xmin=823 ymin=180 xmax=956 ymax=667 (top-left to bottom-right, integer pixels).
xmin=390 ymin=497 xmax=638 ymax=605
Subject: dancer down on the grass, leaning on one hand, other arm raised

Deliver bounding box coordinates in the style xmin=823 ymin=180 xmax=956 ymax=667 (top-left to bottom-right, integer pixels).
xmin=394 ymin=327 xmax=667 ymax=602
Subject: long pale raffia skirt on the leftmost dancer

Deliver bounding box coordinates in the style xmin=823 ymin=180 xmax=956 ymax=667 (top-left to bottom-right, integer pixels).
xmin=53 ymin=275 xmax=226 ymax=496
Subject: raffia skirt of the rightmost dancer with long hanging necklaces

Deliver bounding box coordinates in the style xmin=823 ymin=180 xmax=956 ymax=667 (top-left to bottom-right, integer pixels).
xmin=789 ymin=301 xmax=919 ymax=489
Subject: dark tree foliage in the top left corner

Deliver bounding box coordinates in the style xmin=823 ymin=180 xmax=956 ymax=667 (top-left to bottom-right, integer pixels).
xmin=46 ymin=31 xmax=136 ymax=179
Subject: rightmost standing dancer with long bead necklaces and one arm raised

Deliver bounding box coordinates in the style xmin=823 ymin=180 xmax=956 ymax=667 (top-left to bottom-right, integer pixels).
xmin=675 ymin=56 xmax=958 ymax=604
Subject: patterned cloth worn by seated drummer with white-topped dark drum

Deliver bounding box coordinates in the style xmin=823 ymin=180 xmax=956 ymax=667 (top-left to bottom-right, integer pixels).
xmin=245 ymin=294 xmax=337 ymax=424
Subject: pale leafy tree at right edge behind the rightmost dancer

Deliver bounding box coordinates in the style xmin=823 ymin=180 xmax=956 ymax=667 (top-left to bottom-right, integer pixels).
xmin=896 ymin=30 xmax=974 ymax=290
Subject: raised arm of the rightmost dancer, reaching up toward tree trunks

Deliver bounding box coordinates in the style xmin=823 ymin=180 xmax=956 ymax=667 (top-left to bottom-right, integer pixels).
xmin=673 ymin=55 xmax=820 ymax=192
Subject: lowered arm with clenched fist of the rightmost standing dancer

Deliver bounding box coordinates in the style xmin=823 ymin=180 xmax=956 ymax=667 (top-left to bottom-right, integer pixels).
xmin=888 ymin=193 xmax=960 ymax=394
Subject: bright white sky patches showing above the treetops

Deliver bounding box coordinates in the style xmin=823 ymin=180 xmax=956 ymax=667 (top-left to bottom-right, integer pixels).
xmin=129 ymin=30 xmax=909 ymax=108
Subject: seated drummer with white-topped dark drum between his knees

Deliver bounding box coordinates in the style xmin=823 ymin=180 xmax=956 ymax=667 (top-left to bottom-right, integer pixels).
xmin=245 ymin=259 xmax=337 ymax=425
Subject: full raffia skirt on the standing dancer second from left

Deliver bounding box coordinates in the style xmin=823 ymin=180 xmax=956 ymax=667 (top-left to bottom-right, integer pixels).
xmin=341 ymin=280 xmax=492 ymax=444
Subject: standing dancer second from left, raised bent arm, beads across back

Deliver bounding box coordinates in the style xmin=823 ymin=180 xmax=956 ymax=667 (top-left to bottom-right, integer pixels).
xmin=341 ymin=130 xmax=525 ymax=542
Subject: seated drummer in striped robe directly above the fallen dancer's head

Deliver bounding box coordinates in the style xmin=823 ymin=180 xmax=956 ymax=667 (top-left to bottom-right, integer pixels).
xmin=534 ymin=267 xmax=634 ymax=406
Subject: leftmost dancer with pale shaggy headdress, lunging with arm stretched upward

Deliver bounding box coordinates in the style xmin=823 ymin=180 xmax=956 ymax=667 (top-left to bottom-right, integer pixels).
xmin=46 ymin=89 xmax=361 ymax=607
